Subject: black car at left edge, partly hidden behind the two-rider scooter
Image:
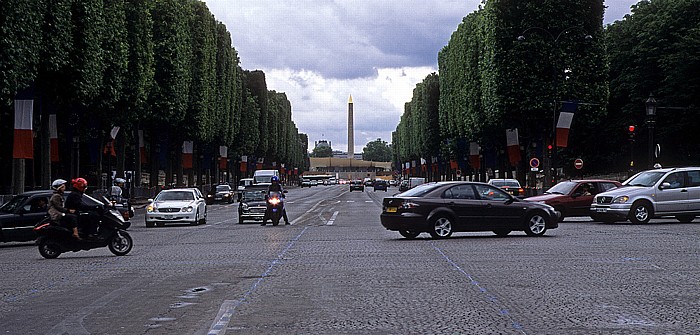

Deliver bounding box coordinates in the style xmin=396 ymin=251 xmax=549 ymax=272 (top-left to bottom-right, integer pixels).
xmin=0 ymin=190 xmax=53 ymax=242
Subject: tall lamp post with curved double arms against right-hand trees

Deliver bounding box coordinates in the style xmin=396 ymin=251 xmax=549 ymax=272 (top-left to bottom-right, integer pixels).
xmin=517 ymin=26 xmax=593 ymax=187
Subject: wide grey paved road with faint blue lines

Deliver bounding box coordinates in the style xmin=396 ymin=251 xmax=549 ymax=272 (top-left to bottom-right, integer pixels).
xmin=0 ymin=185 xmax=700 ymax=334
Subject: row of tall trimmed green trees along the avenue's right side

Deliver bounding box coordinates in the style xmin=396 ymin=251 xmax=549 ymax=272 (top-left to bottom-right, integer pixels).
xmin=393 ymin=0 xmax=700 ymax=182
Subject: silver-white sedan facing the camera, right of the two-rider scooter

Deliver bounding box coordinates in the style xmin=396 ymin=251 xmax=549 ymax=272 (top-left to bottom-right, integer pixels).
xmin=146 ymin=188 xmax=207 ymax=227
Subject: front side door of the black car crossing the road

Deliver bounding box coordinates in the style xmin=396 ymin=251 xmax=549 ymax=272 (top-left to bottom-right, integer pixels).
xmin=474 ymin=184 xmax=525 ymax=230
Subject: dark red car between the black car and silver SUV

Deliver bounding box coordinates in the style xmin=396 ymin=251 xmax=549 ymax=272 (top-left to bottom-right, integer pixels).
xmin=525 ymin=179 xmax=622 ymax=221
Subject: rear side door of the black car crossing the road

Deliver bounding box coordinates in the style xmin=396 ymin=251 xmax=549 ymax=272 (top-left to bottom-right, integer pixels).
xmin=443 ymin=184 xmax=483 ymax=230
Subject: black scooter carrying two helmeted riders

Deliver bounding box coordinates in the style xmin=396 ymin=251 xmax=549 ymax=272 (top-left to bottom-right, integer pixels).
xmin=34 ymin=195 xmax=134 ymax=259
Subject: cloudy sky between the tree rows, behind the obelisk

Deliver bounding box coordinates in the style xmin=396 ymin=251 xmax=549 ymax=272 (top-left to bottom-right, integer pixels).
xmin=205 ymin=0 xmax=637 ymax=153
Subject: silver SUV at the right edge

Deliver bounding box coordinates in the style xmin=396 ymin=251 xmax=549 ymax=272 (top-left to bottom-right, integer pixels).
xmin=590 ymin=167 xmax=700 ymax=224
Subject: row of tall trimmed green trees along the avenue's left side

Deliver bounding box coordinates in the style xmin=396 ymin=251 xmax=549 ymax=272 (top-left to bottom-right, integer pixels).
xmin=0 ymin=0 xmax=308 ymax=192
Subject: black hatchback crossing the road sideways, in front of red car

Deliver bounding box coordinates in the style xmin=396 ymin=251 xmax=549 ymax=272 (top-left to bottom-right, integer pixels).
xmin=380 ymin=182 xmax=559 ymax=239
